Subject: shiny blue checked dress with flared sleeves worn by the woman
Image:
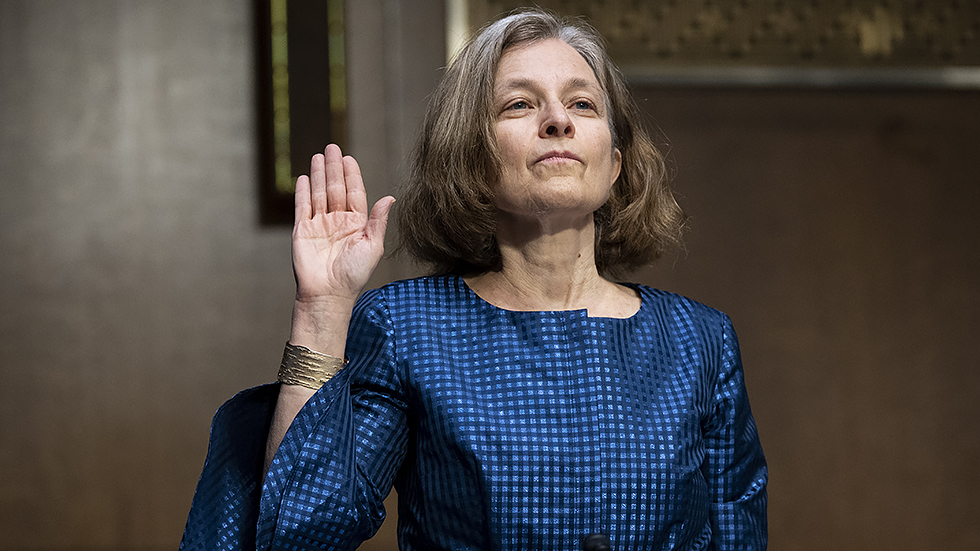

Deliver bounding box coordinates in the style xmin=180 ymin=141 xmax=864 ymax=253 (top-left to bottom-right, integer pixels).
xmin=181 ymin=276 xmax=767 ymax=551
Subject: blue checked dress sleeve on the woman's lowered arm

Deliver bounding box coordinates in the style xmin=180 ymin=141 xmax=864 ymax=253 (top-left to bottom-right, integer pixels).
xmin=701 ymin=316 xmax=768 ymax=551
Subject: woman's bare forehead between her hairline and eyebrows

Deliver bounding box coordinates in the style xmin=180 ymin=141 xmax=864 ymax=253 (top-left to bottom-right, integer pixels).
xmin=494 ymin=39 xmax=601 ymax=93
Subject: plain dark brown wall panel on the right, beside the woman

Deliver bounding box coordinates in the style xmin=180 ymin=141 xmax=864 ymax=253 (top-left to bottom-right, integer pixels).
xmin=636 ymin=88 xmax=980 ymax=550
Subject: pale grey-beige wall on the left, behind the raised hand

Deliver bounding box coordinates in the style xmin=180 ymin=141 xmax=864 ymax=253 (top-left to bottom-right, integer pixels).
xmin=0 ymin=0 xmax=436 ymax=549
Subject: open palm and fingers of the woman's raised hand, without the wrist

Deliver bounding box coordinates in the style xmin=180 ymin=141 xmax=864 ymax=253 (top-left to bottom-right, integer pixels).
xmin=293 ymin=145 xmax=393 ymax=302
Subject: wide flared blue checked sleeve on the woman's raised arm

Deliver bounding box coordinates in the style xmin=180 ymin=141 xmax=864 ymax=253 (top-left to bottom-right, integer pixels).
xmin=181 ymin=291 xmax=408 ymax=550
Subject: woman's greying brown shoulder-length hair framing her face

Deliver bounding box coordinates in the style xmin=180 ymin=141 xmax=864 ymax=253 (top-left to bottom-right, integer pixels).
xmin=396 ymin=9 xmax=685 ymax=275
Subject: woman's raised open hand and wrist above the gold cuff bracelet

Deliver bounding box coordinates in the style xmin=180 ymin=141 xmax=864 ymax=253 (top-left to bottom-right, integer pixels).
xmin=290 ymin=144 xmax=394 ymax=355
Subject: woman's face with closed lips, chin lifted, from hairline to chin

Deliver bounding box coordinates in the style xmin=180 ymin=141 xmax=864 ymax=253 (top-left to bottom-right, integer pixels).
xmin=494 ymin=39 xmax=622 ymax=226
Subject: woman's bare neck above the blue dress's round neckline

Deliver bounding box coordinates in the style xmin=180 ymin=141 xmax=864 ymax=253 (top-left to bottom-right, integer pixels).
xmin=466 ymin=214 xmax=639 ymax=317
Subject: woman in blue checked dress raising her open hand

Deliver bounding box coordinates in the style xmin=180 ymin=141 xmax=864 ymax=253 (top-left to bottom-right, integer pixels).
xmin=182 ymin=11 xmax=767 ymax=549
